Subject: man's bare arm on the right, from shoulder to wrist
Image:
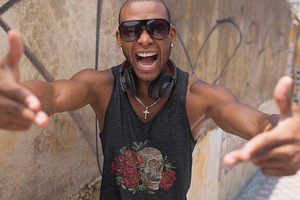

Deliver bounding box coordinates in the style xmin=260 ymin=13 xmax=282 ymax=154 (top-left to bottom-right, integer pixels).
xmin=187 ymin=77 xmax=278 ymax=140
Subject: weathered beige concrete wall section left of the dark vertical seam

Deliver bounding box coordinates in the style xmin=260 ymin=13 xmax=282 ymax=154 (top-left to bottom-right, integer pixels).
xmin=0 ymin=0 xmax=100 ymax=199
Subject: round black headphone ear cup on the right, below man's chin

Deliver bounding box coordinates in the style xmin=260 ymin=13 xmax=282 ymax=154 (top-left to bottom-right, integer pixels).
xmin=148 ymin=73 xmax=172 ymax=100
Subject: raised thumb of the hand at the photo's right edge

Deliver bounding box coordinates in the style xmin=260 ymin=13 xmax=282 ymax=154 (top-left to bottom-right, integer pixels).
xmin=274 ymin=76 xmax=293 ymax=120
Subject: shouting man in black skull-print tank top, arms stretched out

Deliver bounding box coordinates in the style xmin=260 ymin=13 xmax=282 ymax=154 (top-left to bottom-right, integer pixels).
xmin=0 ymin=0 xmax=300 ymax=199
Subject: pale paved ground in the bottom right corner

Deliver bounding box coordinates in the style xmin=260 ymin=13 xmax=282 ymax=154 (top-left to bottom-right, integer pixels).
xmin=237 ymin=171 xmax=300 ymax=200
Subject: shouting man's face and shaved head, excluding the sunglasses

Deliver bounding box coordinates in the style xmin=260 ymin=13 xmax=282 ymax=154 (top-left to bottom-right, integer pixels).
xmin=116 ymin=1 xmax=176 ymax=81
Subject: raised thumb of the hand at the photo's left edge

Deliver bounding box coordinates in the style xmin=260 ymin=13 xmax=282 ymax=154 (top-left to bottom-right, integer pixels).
xmin=7 ymin=30 xmax=24 ymax=67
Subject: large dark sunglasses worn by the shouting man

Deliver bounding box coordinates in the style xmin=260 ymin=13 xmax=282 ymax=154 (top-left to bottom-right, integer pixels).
xmin=119 ymin=19 xmax=170 ymax=42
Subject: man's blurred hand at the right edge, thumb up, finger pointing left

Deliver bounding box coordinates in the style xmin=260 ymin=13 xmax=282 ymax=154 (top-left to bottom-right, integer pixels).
xmin=223 ymin=76 xmax=300 ymax=176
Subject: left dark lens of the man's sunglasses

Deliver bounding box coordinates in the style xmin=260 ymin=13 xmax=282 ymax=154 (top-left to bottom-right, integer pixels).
xmin=119 ymin=21 xmax=141 ymax=41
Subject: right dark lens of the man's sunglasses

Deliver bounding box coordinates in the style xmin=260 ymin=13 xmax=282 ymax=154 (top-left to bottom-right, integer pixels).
xmin=147 ymin=19 xmax=170 ymax=39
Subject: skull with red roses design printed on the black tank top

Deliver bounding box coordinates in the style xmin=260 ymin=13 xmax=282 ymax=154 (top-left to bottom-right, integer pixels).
xmin=111 ymin=140 xmax=176 ymax=195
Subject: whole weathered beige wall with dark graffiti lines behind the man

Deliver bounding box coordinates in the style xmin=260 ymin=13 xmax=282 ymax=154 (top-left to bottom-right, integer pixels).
xmin=0 ymin=0 xmax=290 ymax=200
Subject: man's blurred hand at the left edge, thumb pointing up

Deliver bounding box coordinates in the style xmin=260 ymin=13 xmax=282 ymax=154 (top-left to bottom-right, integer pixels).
xmin=0 ymin=31 xmax=48 ymax=130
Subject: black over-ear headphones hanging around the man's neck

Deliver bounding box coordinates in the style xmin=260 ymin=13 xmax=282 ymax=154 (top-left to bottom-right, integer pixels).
xmin=119 ymin=59 xmax=178 ymax=100
